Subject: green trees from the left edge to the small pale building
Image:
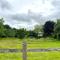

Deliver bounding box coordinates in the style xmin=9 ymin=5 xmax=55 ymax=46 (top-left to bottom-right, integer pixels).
xmin=0 ymin=18 xmax=37 ymax=38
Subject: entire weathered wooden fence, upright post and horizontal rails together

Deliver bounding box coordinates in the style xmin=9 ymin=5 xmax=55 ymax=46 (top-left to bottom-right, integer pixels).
xmin=0 ymin=41 xmax=60 ymax=60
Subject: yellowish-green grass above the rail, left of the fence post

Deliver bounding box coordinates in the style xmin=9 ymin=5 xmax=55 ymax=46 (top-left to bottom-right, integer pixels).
xmin=0 ymin=38 xmax=22 ymax=49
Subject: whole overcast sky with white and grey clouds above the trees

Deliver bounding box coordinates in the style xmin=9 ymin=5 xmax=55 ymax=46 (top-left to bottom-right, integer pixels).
xmin=0 ymin=0 xmax=60 ymax=29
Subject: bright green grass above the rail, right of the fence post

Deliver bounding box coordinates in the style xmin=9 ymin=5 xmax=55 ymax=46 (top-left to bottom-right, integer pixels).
xmin=28 ymin=40 xmax=60 ymax=48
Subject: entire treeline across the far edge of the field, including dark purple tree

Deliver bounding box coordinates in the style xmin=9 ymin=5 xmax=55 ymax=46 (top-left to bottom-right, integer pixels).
xmin=0 ymin=18 xmax=60 ymax=39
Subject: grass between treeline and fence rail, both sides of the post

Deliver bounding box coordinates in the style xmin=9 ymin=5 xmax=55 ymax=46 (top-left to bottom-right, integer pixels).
xmin=0 ymin=38 xmax=60 ymax=49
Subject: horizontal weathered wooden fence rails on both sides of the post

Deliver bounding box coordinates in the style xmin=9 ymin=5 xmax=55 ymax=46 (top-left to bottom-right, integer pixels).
xmin=0 ymin=48 xmax=60 ymax=53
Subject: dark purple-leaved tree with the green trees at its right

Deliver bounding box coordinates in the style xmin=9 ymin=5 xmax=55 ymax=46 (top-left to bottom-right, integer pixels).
xmin=43 ymin=19 xmax=60 ymax=39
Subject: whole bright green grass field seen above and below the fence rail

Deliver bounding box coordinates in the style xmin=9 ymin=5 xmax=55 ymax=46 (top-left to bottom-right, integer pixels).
xmin=0 ymin=38 xmax=60 ymax=60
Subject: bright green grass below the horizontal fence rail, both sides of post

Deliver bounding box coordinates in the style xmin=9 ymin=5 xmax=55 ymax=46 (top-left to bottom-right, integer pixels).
xmin=0 ymin=51 xmax=60 ymax=60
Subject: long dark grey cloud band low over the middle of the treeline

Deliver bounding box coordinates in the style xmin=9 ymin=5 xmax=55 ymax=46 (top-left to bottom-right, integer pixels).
xmin=8 ymin=12 xmax=46 ymax=24
